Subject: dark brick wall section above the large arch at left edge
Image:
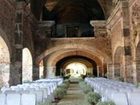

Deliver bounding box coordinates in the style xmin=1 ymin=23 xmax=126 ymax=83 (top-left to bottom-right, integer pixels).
xmin=0 ymin=0 xmax=16 ymax=55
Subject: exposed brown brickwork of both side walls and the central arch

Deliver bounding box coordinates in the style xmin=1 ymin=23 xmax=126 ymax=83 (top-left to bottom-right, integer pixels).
xmin=0 ymin=0 xmax=140 ymax=84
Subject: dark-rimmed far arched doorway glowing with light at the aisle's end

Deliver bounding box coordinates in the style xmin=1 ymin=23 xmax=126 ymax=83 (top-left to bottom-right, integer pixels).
xmin=56 ymin=56 xmax=97 ymax=77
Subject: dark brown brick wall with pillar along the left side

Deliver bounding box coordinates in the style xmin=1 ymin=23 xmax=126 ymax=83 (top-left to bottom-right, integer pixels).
xmin=0 ymin=0 xmax=37 ymax=85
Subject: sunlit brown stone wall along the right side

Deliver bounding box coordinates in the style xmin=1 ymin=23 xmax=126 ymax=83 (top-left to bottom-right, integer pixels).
xmin=107 ymin=0 xmax=140 ymax=83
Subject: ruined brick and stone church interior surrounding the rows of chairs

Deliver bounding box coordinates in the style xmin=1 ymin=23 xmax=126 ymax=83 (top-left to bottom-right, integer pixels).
xmin=0 ymin=0 xmax=140 ymax=86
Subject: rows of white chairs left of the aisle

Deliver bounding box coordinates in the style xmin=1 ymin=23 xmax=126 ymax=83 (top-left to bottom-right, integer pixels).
xmin=0 ymin=79 xmax=63 ymax=105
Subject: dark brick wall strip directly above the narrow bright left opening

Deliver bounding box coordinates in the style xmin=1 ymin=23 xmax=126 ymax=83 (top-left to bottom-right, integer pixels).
xmin=23 ymin=5 xmax=35 ymax=54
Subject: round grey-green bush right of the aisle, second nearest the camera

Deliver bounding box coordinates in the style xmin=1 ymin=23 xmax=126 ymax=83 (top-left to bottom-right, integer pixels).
xmin=86 ymin=92 xmax=101 ymax=104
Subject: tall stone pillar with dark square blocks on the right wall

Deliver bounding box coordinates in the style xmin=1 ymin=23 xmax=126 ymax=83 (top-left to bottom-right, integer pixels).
xmin=122 ymin=0 xmax=133 ymax=82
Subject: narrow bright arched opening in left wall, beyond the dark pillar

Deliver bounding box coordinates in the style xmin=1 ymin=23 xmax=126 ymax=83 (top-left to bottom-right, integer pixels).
xmin=22 ymin=48 xmax=33 ymax=82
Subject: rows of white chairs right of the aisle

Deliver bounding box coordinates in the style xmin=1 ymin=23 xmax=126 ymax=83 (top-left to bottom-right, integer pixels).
xmin=85 ymin=78 xmax=140 ymax=105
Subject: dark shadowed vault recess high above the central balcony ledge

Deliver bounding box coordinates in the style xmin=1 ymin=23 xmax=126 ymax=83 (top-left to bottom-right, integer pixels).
xmin=43 ymin=0 xmax=104 ymax=23
